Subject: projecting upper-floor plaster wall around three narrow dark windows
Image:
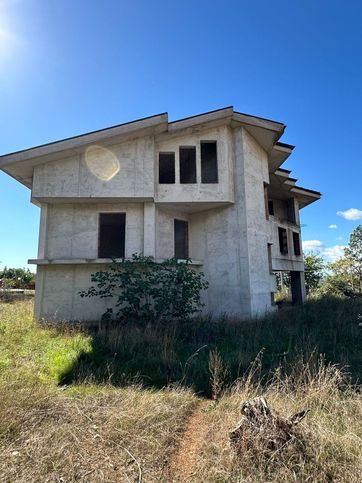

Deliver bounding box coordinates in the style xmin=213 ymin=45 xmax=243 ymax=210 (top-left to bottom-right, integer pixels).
xmin=155 ymin=126 xmax=234 ymax=202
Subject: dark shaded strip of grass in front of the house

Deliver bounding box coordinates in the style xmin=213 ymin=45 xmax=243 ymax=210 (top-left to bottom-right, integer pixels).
xmin=60 ymin=298 xmax=362 ymax=396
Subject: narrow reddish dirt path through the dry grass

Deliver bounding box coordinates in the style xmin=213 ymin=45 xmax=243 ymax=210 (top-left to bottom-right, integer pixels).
xmin=168 ymin=400 xmax=210 ymax=482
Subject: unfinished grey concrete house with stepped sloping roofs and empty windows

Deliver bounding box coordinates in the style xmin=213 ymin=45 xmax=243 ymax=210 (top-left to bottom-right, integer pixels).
xmin=0 ymin=107 xmax=320 ymax=320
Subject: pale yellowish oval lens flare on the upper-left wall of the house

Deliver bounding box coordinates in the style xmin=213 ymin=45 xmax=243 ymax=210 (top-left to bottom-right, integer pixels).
xmin=85 ymin=146 xmax=120 ymax=181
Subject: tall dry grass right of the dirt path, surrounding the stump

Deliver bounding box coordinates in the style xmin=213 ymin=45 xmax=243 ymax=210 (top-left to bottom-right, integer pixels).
xmin=190 ymin=360 xmax=362 ymax=483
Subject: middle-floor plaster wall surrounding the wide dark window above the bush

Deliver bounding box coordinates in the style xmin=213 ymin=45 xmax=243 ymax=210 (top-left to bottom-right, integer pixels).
xmin=46 ymin=203 xmax=143 ymax=259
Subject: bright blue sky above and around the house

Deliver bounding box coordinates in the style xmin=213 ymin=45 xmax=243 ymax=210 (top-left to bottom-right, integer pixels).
xmin=0 ymin=0 xmax=362 ymax=266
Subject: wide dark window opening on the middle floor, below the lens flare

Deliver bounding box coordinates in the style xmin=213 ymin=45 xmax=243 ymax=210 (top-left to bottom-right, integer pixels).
xmin=98 ymin=213 xmax=126 ymax=258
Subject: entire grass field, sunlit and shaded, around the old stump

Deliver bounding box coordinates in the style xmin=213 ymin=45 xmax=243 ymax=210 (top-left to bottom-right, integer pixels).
xmin=0 ymin=299 xmax=362 ymax=483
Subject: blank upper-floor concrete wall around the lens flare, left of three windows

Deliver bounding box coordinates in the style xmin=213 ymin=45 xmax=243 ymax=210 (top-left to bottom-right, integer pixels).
xmin=32 ymin=136 xmax=155 ymax=198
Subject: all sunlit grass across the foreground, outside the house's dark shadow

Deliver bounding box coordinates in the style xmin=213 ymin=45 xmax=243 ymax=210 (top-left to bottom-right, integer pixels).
xmin=0 ymin=302 xmax=362 ymax=483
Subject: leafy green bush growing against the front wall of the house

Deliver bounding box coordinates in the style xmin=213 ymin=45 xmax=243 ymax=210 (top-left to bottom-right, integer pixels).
xmin=80 ymin=254 xmax=208 ymax=322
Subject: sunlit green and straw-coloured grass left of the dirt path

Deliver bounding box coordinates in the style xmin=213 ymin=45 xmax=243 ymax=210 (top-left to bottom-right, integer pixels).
xmin=0 ymin=302 xmax=197 ymax=483
